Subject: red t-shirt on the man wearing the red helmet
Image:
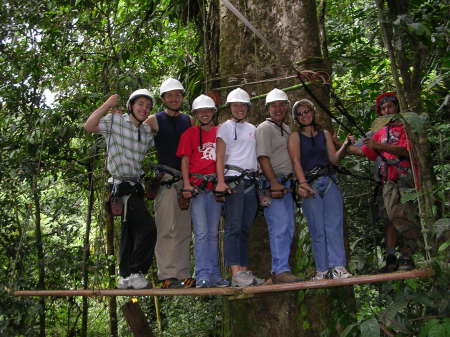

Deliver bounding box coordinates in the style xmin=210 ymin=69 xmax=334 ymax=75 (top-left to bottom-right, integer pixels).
xmin=361 ymin=124 xmax=411 ymax=181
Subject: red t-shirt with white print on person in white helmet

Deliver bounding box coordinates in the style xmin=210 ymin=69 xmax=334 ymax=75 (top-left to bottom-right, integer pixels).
xmin=177 ymin=126 xmax=218 ymax=189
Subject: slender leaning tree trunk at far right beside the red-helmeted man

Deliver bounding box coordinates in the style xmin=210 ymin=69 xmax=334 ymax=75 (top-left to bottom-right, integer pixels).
xmin=375 ymin=0 xmax=436 ymax=253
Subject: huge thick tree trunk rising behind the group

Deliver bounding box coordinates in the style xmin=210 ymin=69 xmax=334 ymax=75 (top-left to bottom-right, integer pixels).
xmin=217 ymin=0 xmax=352 ymax=337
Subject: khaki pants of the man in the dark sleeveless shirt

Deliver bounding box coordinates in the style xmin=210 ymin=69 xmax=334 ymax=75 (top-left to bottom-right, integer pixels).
xmin=154 ymin=179 xmax=192 ymax=280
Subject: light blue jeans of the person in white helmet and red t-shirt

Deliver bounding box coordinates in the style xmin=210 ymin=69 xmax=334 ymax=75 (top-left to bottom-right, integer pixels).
xmin=191 ymin=191 xmax=222 ymax=282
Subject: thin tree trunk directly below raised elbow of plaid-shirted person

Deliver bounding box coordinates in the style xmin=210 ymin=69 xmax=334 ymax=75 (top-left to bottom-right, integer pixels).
xmin=81 ymin=149 xmax=97 ymax=337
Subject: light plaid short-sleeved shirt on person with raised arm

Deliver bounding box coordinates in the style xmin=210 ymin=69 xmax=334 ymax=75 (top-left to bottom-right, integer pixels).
xmin=98 ymin=114 xmax=154 ymax=179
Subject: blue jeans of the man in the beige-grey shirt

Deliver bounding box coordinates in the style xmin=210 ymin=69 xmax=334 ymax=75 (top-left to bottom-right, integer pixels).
xmin=264 ymin=181 xmax=295 ymax=275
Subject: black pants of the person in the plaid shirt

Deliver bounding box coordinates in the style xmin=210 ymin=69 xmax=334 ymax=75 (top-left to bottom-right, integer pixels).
xmin=119 ymin=194 xmax=156 ymax=277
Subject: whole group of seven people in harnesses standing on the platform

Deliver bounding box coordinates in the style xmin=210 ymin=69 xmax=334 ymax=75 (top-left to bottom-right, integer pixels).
xmin=85 ymin=78 xmax=416 ymax=289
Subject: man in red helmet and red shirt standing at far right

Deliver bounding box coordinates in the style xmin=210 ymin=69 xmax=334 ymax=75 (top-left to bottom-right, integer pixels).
xmin=347 ymin=92 xmax=420 ymax=272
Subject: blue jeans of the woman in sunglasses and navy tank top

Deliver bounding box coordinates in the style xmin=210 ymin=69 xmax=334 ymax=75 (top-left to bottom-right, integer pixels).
xmin=302 ymin=176 xmax=346 ymax=272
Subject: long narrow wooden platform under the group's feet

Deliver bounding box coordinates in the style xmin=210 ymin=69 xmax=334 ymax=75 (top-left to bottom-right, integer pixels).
xmin=11 ymin=269 xmax=434 ymax=298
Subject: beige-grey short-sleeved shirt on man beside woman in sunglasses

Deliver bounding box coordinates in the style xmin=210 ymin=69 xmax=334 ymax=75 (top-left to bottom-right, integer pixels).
xmin=256 ymin=120 xmax=293 ymax=176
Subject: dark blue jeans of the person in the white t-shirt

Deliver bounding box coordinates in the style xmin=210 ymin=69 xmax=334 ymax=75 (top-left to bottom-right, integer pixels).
xmin=224 ymin=179 xmax=258 ymax=267
